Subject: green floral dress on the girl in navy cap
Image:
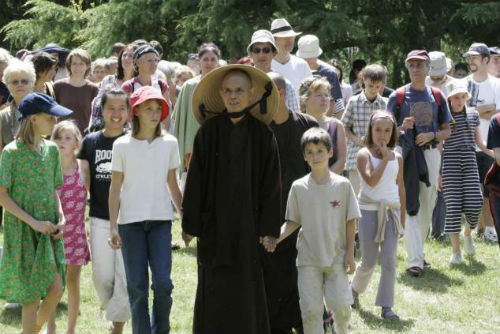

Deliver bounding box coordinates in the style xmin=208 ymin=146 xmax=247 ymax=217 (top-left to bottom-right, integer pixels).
xmin=0 ymin=140 xmax=66 ymax=304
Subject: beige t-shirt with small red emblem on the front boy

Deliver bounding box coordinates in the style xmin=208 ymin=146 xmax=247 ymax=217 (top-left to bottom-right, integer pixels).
xmin=285 ymin=172 xmax=361 ymax=267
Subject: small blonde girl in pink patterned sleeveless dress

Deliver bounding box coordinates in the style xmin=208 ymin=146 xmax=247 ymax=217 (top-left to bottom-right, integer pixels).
xmin=49 ymin=121 xmax=90 ymax=333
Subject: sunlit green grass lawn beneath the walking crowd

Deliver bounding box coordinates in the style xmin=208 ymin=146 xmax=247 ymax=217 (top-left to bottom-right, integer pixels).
xmin=0 ymin=222 xmax=500 ymax=334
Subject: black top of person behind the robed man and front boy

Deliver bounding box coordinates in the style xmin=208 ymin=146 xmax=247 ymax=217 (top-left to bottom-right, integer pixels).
xmin=270 ymin=111 xmax=319 ymax=217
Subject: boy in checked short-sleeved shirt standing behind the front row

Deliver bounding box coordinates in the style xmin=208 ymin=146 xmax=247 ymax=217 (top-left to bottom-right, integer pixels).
xmin=342 ymin=64 xmax=387 ymax=194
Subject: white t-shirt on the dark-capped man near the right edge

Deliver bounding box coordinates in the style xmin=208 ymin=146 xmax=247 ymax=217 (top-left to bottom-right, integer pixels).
xmin=466 ymin=74 xmax=500 ymax=140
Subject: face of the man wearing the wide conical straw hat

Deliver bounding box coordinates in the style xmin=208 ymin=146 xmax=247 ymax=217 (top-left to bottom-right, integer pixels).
xmin=220 ymin=72 xmax=253 ymax=112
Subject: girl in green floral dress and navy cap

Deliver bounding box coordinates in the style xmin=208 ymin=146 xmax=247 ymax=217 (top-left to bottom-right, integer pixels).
xmin=0 ymin=93 xmax=71 ymax=333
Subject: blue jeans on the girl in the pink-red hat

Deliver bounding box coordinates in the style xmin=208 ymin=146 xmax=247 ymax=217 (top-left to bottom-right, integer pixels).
xmin=118 ymin=220 xmax=174 ymax=334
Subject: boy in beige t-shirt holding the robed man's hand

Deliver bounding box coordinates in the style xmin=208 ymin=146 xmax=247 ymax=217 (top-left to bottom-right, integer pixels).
xmin=272 ymin=128 xmax=361 ymax=334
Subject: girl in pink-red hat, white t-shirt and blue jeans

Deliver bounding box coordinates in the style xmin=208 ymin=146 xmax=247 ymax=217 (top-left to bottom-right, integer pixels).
xmin=109 ymin=86 xmax=182 ymax=334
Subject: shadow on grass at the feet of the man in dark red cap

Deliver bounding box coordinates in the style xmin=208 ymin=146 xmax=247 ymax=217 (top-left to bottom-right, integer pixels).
xmin=398 ymin=268 xmax=464 ymax=293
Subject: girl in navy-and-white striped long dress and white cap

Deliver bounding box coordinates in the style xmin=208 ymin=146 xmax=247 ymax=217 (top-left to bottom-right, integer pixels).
xmin=439 ymin=81 xmax=493 ymax=264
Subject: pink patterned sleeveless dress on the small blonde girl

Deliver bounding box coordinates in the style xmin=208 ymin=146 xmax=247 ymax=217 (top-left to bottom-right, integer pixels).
xmin=57 ymin=164 xmax=90 ymax=266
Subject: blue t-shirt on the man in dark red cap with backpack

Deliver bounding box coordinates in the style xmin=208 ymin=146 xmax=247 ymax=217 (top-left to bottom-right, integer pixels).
xmin=387 ymin=84 xmax=452 ymax=135
